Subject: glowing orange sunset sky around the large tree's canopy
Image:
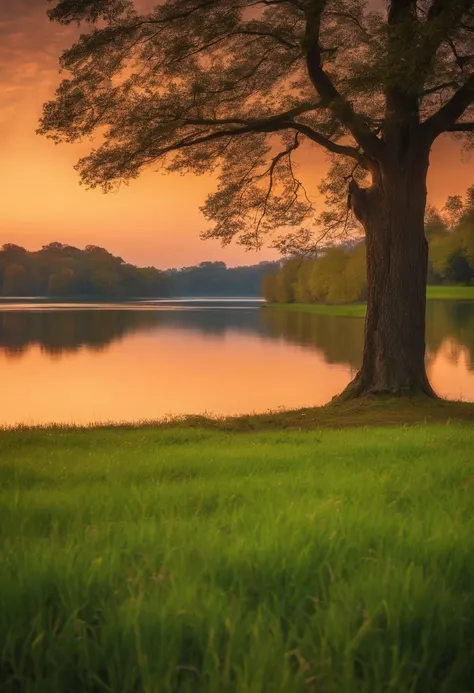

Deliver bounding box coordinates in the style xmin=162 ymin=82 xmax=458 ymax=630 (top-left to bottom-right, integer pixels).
xmin=0 ymin=0 xmax=474 ymax=268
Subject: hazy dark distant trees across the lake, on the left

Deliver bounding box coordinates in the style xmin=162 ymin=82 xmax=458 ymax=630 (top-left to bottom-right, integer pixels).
xmin=0 ymin=242 xmax=280 ymax=298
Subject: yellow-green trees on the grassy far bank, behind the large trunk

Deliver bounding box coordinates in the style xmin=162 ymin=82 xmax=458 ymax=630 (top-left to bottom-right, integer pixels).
xmin=262 ymin=186 xmax=474 ymax=303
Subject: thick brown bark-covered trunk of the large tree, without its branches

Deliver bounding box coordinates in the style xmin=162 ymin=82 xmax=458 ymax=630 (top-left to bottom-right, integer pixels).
xmin=342 ymin=148 xmax=436 ymax=399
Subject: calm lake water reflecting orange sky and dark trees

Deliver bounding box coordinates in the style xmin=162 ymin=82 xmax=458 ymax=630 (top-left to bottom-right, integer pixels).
xmin=0 ymin=300 xmax=474 ymax=424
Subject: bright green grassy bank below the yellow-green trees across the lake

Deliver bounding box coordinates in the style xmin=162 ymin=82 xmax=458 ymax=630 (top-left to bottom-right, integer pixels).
xmin=264 ymin=286 xmax=474 ymax=318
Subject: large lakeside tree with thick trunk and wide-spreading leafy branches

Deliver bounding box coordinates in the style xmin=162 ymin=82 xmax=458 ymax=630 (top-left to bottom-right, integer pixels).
xmin=40 ymin=0 xmax=474 ymax=396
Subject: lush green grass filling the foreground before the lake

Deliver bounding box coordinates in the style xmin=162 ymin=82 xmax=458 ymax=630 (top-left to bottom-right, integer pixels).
xmin=0 ymin=425 xmax=474 ymax=693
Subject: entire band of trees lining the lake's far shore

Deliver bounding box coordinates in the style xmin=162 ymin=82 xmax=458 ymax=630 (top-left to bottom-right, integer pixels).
xmin=0 ymin=185 xmax=474 ymax=303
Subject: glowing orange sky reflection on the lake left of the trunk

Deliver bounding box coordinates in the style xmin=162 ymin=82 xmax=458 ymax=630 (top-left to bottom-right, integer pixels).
xmin=0 ymin=328 xmax=347 ymax=424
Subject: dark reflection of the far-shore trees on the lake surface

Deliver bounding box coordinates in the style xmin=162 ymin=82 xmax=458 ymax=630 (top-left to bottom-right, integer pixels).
xmin=0 ymin=301 xmax=474 ymax=370
